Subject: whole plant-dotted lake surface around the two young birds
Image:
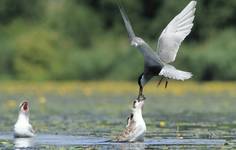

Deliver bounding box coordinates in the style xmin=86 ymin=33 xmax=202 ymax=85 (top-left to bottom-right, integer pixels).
xmin=0 ymin=82 xmax=236 ymax=149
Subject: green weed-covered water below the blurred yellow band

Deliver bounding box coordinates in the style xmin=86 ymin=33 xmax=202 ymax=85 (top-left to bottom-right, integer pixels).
xmin=0 ymin=92 xmax=236 ymax=149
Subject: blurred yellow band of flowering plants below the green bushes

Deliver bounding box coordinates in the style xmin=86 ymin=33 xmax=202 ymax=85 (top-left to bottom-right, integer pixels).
xmin=0 ymin=80 xmax=236 ymax=96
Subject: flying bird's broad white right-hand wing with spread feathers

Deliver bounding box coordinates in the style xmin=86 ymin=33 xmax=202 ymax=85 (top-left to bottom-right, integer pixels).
xmin=157 ymin=1 xmax=197 ymax=63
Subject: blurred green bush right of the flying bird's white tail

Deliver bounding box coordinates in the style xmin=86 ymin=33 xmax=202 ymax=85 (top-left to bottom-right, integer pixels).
xmin=177 ymin=29 xmax=236 ymax=80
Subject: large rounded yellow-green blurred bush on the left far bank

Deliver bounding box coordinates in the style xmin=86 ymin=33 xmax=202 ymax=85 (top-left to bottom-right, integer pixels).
xmin=1 ymin=20 xmax=71 ymax=80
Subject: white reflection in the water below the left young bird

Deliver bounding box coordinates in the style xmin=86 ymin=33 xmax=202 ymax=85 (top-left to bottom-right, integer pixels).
xmin=14 ymin=138 xmax=34 ymax=150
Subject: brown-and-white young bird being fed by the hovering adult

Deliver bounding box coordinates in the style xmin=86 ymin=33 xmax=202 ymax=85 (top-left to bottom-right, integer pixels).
xmin=116 ymin=100 xmax=146 ymax=142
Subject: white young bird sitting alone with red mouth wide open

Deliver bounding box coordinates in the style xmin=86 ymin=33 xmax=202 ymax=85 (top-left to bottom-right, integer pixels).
xmin=14 ymin=101 xmax=35 ymax=138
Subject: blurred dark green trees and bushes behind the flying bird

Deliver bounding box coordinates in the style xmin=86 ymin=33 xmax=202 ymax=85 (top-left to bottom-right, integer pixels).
xmin=0 ymin=0 xmax=236 ymax=81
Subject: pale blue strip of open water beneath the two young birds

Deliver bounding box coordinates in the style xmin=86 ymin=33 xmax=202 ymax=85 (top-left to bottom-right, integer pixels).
xmin=0 ymin=134 xmax=226 ymax=149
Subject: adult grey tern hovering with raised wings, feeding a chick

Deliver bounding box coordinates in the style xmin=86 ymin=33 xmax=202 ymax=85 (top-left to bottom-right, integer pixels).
xmin=118 ymin=1 xmax=197 ymax=100
